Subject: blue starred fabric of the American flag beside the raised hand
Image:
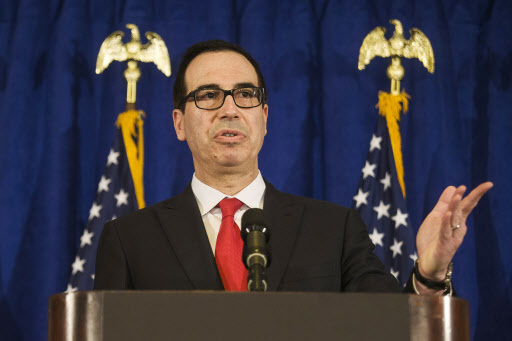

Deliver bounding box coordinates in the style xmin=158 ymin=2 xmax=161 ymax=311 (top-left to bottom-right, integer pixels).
xmin=353 ymin=115 xmax=418 ymax=285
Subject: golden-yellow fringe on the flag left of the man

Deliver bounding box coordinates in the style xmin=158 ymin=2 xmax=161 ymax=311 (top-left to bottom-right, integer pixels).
xmin=116 ymin=110 xmax=146 ymax=209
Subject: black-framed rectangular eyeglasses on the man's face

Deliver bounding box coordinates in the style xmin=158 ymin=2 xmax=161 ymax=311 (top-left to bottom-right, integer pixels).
xmin=180 ymin=87 xmax=265 ymax=110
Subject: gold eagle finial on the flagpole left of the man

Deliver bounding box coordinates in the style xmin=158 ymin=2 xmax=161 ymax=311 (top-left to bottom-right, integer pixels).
xmin=96 ymin=24 xmax=171 ymax=110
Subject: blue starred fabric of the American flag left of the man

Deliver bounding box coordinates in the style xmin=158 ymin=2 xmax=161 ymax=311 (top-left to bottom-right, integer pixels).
xmin=66 ymin=124 xmax=138 ymax=292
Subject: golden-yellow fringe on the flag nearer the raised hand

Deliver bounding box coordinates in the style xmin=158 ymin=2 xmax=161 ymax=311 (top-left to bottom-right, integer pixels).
xmin=375 ymin=90 xmax=411 ymax=198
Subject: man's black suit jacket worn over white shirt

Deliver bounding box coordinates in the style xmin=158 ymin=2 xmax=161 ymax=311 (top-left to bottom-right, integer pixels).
xmin=94 ymin=183 xmax=401 ymax=292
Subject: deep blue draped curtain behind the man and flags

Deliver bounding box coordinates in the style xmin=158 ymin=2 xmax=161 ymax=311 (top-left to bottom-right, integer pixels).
xmin=0 ymin=0 xmax=512 ymax=340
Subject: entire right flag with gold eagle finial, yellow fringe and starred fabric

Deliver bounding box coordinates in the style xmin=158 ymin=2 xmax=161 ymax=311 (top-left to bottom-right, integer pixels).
xmin=353 ymin=20 xmax=434 ymax=285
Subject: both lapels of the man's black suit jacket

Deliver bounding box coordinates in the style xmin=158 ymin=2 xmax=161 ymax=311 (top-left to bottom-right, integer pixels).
xmin=154 ymin=181 xmax=304 ymax=291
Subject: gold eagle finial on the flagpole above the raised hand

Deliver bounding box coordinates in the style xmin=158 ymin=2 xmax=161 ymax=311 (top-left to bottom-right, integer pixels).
xmin=358 ymin=19 xmax=434 ymax=95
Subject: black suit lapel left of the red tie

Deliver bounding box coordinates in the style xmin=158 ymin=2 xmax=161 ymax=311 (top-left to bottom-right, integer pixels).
xmin=154 ymin=185 xmax=224 ymax=290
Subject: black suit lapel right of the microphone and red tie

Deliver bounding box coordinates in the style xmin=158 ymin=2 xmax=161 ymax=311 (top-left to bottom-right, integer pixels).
xmin=263 ymin=181 xmax=304 ymax=291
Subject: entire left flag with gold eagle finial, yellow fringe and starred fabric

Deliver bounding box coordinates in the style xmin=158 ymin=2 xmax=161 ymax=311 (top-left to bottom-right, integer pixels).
xmin=66 ymin=24 xmax=171 ymax=292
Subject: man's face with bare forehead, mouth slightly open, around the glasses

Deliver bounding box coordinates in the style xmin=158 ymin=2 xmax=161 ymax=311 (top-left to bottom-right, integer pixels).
xmin=173 ymin=51 xmax=268 ymax=174
